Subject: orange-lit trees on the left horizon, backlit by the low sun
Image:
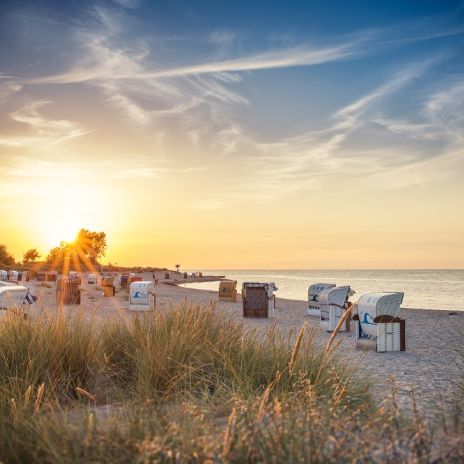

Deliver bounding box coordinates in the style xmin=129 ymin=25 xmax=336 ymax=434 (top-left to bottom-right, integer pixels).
xmin=0 ymin=229 xmax=108 ymax=269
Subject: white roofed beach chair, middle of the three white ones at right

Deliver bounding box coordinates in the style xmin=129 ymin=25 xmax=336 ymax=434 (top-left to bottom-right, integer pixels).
xmin=319 ymin=286 xmax=355 ymax=332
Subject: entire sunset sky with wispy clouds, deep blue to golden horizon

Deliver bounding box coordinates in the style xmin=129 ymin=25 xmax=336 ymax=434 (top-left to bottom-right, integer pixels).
xmin=0 ymin=0 xmax=464 ymax=270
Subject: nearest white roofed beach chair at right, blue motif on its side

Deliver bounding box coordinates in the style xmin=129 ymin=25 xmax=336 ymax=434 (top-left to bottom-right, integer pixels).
xmin=353 ymin=292 xmax=406 ymax=352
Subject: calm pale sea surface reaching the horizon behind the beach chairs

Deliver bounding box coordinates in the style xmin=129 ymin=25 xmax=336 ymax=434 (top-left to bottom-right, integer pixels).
xmin=183 ymin=269 xmax=464 ymax=311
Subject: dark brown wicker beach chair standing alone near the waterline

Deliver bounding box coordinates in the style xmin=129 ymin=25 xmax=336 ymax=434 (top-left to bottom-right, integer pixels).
xmin=242 ymin=282 xmax=277 ymax=317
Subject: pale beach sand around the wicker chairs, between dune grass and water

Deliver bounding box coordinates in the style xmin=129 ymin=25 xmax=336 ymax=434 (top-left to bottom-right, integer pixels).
xmin=27 ymin=272 xmax=464 ymax=415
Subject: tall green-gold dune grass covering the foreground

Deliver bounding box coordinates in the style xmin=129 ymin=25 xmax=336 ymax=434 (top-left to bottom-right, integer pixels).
xmin=0 ymin=306 xmax=464 ymax=463
